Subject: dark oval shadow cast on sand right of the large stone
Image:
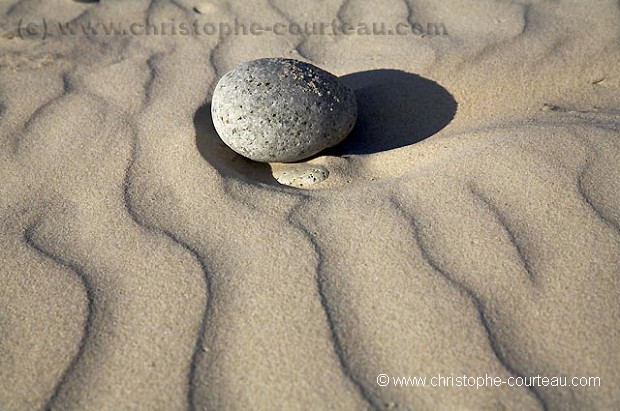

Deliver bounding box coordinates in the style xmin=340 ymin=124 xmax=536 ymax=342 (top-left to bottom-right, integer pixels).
xmin=322 ymin=69 xmax=457 ymax=156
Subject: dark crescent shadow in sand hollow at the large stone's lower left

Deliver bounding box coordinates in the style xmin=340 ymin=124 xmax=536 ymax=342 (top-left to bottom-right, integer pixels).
xmin=194 ymin=103 xmax=279 ymax=185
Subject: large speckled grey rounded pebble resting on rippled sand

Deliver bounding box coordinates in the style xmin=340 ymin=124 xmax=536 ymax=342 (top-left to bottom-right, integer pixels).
xmin=211 ymin=58 xmax=357 ymax=162
